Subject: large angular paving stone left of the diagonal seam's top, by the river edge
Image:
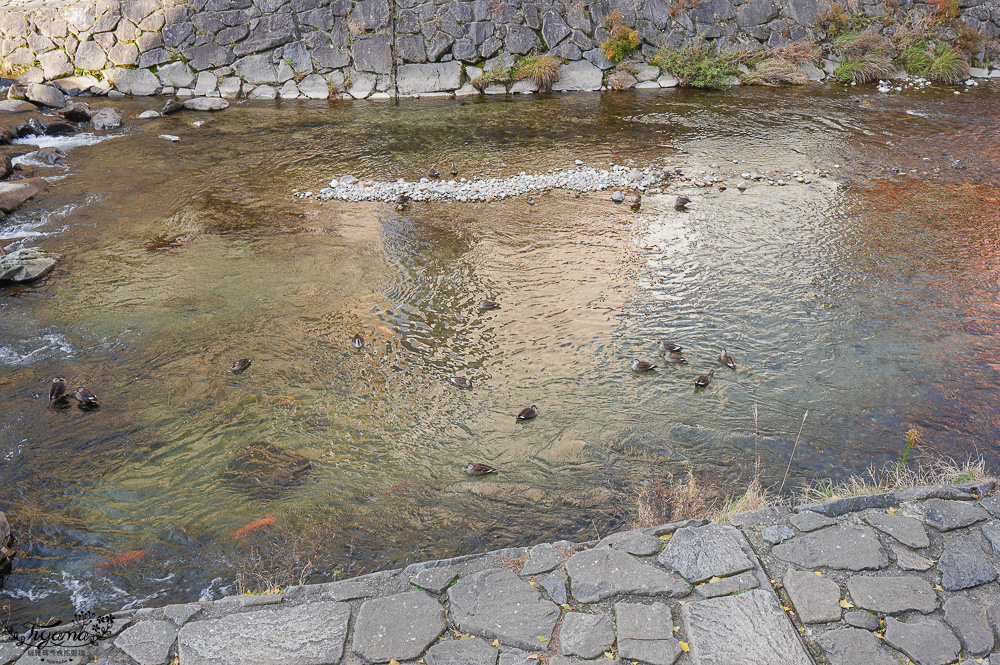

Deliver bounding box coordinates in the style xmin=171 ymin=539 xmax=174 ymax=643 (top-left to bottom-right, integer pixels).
xmin=660 ymin=522 xmax=753 ymax=580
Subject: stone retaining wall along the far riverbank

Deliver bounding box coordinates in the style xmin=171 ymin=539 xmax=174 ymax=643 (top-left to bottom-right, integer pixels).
xmin=0 ymin=0 xmax=1000 ymax=99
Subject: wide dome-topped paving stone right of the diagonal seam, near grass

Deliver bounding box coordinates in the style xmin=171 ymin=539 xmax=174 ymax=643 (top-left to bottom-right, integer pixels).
xmin=771 ymin=526 xmax=889 ymax=571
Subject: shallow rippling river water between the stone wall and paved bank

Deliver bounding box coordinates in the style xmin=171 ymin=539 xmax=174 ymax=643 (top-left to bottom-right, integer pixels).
xmin=0 ymin=85 xmax=1000 ymax=619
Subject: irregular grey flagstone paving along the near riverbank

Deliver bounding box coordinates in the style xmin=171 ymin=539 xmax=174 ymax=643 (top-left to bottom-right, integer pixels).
xmin=0 ymin=482 xmax=1000 ymax=665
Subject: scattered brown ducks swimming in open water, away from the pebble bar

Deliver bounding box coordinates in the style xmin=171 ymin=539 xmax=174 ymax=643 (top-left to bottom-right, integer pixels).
xmin=49 ymin=300 xmax=736 ymax=476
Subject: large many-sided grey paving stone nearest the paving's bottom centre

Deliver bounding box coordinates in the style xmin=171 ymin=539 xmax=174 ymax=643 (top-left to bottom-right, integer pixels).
xmin=448 ymin=564 xmax=560 ymax=649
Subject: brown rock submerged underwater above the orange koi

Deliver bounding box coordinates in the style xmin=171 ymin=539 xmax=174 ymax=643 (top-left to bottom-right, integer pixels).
xmin=222 ymin=441 xmax=312 ymax=499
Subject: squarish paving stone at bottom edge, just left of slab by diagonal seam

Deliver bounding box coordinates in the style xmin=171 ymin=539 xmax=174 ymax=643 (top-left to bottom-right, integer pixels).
xmin=615 ymin=603 xmax=681 ymax=665
